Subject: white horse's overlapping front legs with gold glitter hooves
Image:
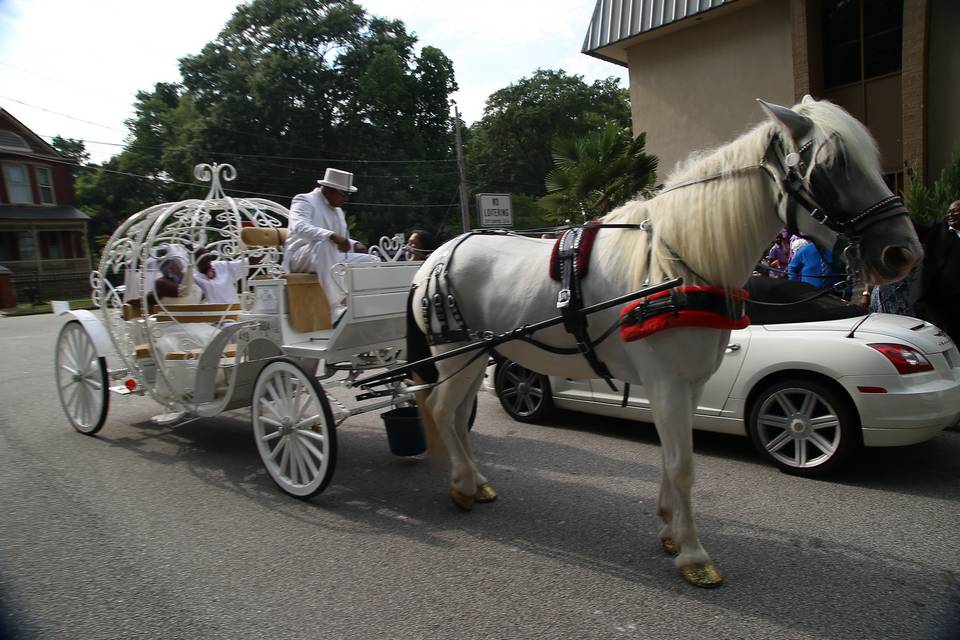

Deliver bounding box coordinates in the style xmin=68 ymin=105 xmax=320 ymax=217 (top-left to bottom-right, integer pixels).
xmin=648 ymin=376 xmax=723 ymax=587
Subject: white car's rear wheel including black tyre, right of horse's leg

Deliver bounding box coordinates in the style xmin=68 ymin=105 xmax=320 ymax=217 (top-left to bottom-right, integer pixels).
xmin=747 ymin=379 xmax=863 ymax=477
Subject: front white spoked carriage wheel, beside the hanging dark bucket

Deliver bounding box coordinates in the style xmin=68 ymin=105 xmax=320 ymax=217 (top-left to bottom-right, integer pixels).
xmin=251 ymin=360 xmax=337 ymax=498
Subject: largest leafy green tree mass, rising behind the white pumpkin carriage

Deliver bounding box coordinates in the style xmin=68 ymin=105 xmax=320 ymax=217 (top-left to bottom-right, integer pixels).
xmin=77 ymin=0 xmax=457 ymax=240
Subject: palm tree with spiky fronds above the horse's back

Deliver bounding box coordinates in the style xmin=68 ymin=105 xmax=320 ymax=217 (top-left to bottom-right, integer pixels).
xmin=539 ymin=124 xmax=657 ymax=221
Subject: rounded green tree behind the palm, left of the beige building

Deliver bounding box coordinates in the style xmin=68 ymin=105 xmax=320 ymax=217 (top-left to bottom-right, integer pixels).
xmin=466 ymin=69 xmax=630 ymax=197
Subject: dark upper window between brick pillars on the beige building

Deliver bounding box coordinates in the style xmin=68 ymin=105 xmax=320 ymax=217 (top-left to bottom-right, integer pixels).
xmin=822 ymin=0 xmax=903 ymax=89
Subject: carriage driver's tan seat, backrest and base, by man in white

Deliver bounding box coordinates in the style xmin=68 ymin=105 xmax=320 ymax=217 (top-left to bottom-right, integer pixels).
xmin=240 ymin=227 xmax=333 ymax=333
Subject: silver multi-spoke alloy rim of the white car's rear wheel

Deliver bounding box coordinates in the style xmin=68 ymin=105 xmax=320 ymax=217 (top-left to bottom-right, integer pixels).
xmin=757 ymin=388 xmax=841 ymax=469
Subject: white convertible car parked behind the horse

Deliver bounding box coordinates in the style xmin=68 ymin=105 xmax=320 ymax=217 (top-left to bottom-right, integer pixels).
xmin=485 ymin=278 xmax=960 ymax=476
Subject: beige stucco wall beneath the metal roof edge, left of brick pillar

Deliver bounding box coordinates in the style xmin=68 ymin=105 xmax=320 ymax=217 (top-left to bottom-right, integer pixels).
xmin=627 ymin=0 xmax=794 ymax=182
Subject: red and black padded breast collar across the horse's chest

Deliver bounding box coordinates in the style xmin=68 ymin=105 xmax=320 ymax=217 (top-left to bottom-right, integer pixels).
xmin=620 ymin=285 xmax=750 ymax=342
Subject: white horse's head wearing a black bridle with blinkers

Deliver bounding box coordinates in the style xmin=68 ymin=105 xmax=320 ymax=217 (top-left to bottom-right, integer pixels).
xmin=759 ymin=96 xmax=923 ymax=283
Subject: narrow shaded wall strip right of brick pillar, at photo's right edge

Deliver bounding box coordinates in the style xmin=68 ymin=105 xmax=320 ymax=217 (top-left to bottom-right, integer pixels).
xmin=926 ymin=0 xmax=960 ymax=182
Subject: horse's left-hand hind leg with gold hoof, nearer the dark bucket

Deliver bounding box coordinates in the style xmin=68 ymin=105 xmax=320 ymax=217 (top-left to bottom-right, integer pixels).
xmin=427 ymin=358 xmax=486 ymax=511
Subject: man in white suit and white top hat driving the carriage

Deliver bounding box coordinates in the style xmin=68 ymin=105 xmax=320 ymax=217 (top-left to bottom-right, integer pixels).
xmin=283 ymin=169 xmax=378 ymax=320
